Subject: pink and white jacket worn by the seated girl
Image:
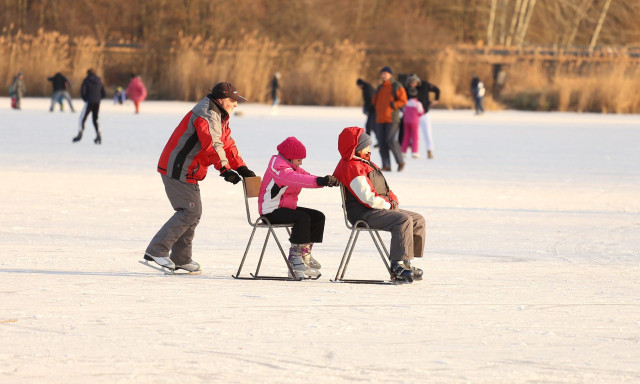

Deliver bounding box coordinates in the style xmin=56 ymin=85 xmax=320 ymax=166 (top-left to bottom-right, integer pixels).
xmin=258 ymin=154 xmax=322 ymax=215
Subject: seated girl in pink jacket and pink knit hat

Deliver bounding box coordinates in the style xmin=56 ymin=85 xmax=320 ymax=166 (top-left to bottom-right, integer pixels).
xmin=258 ymin=137 xmax=338 ymax=278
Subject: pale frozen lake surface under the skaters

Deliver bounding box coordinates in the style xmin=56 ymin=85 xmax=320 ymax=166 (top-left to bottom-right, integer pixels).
xmin=0 ymin=98 xmax=640 ymax=383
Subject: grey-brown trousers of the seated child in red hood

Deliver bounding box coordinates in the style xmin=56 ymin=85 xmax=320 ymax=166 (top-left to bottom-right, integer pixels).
xmin=362 ymin=209 xmax=425 ymax=261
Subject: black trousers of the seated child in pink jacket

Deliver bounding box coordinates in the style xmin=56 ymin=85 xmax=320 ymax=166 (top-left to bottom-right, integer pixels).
xmin=264 ymin=207 xmax=325 ymax=244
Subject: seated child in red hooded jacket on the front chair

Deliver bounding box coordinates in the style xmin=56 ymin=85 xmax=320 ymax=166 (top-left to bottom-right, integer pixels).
xmin=333 ymin=127 xmax=425 ymax=282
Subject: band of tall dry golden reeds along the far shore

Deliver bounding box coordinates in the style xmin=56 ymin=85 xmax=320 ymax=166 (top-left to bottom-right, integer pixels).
xmin=0 ymin=26 xmax=640 ymax=113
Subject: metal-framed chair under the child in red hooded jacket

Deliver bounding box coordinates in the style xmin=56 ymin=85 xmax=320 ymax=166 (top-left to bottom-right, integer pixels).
xmin=331 ymin=185 xmax=398 ymax=284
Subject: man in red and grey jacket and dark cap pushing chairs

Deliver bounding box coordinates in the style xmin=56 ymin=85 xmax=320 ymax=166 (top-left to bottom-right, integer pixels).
xmin=144 ymin=82 xmax=255 ymax=274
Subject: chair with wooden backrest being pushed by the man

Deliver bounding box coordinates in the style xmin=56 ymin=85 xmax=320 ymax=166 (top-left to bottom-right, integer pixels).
xmin=231 ymin=176 xmax=320 ymax=281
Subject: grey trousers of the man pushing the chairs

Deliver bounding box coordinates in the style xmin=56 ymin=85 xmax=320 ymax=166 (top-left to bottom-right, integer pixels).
xmin=146 ymin=175 xmax=202 ymax=265
